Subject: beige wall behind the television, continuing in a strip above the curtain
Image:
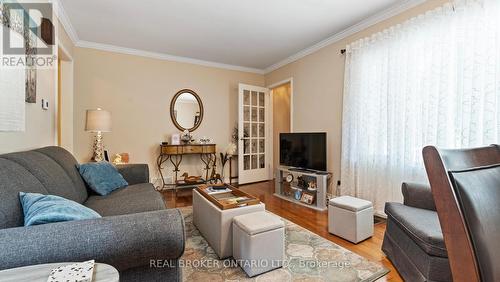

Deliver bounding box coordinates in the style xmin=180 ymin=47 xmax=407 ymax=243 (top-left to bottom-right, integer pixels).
xmin=266 ymin=0 xmax=449 ymax=193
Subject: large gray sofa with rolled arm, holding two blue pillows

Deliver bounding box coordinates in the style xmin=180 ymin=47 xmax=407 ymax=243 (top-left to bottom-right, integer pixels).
xmin=0 ymin=147 xmax=185 ymax=281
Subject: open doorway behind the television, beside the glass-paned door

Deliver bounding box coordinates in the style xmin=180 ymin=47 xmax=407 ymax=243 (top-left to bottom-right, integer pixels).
xmin=269 ymin=79 xmax=293 ymax=175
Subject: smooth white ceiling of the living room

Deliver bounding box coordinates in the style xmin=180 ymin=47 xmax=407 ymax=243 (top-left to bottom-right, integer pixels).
xmin=56 ymin=0 xmax=422 ymax=72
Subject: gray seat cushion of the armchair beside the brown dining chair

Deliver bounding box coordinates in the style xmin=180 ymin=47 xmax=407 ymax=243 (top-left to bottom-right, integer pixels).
xmin=385 ymin=203 xmax=448 ymax=257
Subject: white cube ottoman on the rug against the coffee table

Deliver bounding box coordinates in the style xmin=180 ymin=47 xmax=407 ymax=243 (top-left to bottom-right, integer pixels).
xmin=233 ymin=212 xmax=285 ymax=277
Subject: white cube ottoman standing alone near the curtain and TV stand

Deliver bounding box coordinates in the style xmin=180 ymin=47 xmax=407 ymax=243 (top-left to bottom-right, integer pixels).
xmin=328 ymin=196 xmax=373 ymax=244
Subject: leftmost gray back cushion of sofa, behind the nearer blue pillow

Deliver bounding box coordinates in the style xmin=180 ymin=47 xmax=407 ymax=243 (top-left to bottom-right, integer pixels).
xmin=0 ymin=159 xmax=47 ymax=229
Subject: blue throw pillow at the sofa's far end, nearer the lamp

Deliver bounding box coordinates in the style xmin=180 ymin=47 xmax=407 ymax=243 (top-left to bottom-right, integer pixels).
xmin=78 ymin=162 xmax=128 ymax=196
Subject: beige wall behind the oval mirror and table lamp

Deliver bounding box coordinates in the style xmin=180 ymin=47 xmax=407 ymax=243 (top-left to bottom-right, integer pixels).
xmin=74 ymin=48 xmax=264 ymax=185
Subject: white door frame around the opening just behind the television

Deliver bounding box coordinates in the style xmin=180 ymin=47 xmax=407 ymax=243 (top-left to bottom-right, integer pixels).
xmin=266 ymin=77 xmax=294 ymax=180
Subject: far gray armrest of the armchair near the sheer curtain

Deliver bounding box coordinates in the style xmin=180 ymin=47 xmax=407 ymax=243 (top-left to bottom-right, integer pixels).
xmin=401 ymin=182 xmax=436 ymax=211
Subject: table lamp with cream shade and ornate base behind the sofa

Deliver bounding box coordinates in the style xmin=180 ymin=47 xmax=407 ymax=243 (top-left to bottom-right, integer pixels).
xmin=85 ymin=108 xmax=111 ymax=162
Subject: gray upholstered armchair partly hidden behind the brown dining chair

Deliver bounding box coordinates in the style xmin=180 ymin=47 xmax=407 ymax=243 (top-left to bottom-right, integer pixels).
xmin=382 ymin=183 xmax=452 ymax=281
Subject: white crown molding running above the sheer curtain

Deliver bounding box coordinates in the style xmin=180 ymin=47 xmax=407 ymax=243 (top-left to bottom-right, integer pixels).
xmin=264 ymin=0 xmax=427 ymax=74
